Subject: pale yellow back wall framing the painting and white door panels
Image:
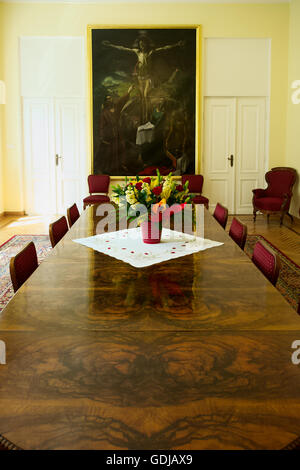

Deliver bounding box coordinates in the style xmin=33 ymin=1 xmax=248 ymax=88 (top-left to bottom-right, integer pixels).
xmin=0 ymin=2 xmax=289 ymax=211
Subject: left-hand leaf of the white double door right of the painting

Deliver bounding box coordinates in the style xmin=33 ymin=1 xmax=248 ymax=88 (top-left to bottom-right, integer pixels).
xmin=203 ymin=98 xmax=236 ymax=213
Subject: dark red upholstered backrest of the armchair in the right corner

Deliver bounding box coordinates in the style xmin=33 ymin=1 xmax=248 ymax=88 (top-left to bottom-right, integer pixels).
xmin=266 ymin=166 xmax=296 ymax=197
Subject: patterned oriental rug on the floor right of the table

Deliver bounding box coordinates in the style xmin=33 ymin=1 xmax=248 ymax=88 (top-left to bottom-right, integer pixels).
xmin=245 ymin=235 xmax=300 ymax=310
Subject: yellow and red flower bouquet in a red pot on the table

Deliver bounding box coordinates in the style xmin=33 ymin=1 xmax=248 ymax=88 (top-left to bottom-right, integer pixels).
xmin=112 ymin=170 xmax=194 ymax=243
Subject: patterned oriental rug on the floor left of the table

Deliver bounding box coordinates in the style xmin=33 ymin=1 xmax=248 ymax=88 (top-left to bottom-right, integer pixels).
xmin=0 ymin=235 xmax=51 ymax=313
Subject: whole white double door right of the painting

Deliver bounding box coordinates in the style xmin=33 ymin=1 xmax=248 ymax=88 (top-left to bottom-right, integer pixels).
xmin=203 ymin=97 xmax=266 ymax=214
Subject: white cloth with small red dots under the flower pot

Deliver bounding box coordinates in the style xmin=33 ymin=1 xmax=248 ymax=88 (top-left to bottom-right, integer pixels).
xmin=73 ymin=228 xmax=223 ymax=268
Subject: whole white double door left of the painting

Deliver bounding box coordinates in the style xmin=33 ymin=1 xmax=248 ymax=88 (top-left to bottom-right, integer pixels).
xmin=23 ymin=98 xmax=87 ymax=215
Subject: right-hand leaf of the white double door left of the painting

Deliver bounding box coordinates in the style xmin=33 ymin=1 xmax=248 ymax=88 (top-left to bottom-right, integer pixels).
xmin=55 ymin=98 xmax=86 ymax=214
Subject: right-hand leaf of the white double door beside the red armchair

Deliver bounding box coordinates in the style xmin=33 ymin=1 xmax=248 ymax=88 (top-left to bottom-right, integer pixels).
xmin=235 ymin=98 xmax=266 ymax=214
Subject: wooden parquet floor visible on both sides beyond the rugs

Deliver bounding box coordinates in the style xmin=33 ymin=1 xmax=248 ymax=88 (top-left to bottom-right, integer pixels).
xmin=0 ymin=211 xmax=300 ymax=265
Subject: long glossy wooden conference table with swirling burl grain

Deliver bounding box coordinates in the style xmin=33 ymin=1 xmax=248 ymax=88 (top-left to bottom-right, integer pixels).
xmin=0 ymin=208 xmax=300 ymax=450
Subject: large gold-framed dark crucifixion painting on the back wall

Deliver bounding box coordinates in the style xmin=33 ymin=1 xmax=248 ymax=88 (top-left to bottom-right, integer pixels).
xmin=88 ymin=26 xmax=200 ymax=178
